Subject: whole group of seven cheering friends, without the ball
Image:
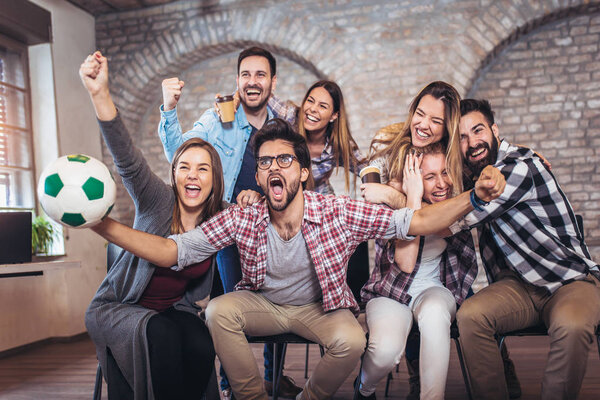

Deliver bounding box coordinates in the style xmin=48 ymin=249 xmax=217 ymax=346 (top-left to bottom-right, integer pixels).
xmin=80 ymin=43 xmax=600 ymax=399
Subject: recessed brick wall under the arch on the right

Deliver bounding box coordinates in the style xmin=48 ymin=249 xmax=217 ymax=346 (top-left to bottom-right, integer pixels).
xmin=469 ymin=14 xmax=600 ymax=260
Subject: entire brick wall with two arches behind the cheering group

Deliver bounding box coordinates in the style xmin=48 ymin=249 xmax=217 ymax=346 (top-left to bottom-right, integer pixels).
xmin=96 ymin=0 xmax=600 ymax=258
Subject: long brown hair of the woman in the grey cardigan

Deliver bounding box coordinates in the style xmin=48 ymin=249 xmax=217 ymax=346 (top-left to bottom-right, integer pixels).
xmin=171 ymin=138 xmax=225 ymax=234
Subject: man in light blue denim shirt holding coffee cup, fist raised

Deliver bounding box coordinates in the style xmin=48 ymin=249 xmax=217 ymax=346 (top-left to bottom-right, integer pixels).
xmin=158 ymin=47 xmax=301 ymax=397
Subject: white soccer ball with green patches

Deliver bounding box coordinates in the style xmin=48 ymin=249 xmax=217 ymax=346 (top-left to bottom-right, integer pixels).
xmin=37 ymin=154 xmax=117 ymax=228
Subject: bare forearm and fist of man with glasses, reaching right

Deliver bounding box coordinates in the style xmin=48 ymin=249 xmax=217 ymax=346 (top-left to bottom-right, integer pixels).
xmin=408 ymin=165 xmax=506 ymax=236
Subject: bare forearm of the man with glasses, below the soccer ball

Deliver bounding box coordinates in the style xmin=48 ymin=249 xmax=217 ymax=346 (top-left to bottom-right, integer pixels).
xmin=91 ymin=217 xmax=177 ymax=268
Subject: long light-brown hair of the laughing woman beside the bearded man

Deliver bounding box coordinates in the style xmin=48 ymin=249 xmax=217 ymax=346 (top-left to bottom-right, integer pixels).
xmin=371 ymin=81 xmax=462 ymax=195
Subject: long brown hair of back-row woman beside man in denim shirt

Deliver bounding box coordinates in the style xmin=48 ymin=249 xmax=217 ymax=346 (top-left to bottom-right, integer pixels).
xmin=298 ymin=80 xmax=362 ymax=191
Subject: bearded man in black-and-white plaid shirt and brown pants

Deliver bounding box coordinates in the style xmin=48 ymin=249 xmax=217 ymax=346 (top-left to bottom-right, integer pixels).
xmin=450 ymin=99 xmax=600 ymax=399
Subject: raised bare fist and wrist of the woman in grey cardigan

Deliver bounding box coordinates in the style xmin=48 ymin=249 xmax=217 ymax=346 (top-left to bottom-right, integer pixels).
xmin=79 ymin=51 xmax=117 ymax=121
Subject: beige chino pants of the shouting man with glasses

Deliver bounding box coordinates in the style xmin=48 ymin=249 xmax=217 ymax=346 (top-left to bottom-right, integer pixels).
xmin=206 ymin=290 xmax=366 ymax=400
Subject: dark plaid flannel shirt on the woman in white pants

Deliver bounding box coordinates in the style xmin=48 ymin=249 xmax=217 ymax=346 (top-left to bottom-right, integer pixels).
xmin=361 ymin=231 xmax=477 ymax=305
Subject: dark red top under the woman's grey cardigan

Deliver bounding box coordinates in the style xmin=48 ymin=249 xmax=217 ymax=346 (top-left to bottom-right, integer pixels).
xmin=138 ymin=257 xmax=212 ymax=312
